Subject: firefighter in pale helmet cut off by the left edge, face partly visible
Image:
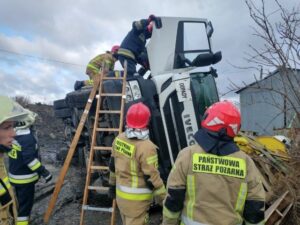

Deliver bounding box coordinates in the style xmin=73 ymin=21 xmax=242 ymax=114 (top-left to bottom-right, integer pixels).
xmin=0 ymin=96 xmax=27 ymax=225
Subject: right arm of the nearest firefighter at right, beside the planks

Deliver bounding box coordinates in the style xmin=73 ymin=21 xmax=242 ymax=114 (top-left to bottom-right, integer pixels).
xmin=243 ymin=158 xmax=265 ymax=225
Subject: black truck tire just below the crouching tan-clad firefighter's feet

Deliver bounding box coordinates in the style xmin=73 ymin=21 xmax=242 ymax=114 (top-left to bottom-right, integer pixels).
xmin=66 ymin=88 xmax=91 ymax=109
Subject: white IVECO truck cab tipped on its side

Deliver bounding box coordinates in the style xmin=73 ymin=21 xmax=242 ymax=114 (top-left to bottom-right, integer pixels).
xmin=123 ymin=17 xmax=221 ymax=179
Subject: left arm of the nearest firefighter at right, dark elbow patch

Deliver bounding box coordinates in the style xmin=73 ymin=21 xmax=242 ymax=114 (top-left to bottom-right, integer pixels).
xmin=163 ymin=150 xmax=189 ymax=225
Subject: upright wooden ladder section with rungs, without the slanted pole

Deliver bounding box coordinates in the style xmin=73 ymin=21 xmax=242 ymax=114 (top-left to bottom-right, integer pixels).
xmin=80 ymin=63 xmax=127 ymax=225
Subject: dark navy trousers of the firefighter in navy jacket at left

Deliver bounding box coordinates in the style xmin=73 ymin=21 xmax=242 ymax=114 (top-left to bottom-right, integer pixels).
xmin=15 ymin=183 xmax=35 ymax=225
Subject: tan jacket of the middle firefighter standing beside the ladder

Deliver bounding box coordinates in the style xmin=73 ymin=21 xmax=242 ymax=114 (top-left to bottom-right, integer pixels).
xmin=110 ymin=133 xmax=165 ymax=217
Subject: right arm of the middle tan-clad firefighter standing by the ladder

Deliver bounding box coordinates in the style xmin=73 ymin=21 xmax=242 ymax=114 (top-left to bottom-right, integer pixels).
xmin=139 ymin=144 xmax=166 ymax=205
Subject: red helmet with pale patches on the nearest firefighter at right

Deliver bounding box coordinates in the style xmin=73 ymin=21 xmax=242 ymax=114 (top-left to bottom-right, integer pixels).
xmin=201 ymin=101 xmax=241 ymax=137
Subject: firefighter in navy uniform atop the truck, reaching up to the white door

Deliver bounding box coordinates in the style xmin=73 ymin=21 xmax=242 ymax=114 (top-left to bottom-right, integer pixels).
xmin=117 ymin=15 xmax=156 ymax=77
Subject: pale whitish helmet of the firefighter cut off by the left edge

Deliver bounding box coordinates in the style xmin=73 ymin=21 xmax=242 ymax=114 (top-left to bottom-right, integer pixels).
xmin=0 ymin=96 xmax=27 ymax=124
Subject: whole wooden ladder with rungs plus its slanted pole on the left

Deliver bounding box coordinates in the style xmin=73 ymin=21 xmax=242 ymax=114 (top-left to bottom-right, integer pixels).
xmin=44 ymin=62 xmax=127 ymax=225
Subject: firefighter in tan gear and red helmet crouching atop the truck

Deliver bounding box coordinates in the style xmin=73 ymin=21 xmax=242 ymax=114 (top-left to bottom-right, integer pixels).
xmin=74 ymin=45 xmax=119 ymax=90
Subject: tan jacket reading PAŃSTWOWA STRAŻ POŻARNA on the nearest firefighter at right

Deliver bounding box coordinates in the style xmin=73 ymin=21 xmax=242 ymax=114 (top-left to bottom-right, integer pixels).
xmin=163 ymin=144 xmax=265 ymax=225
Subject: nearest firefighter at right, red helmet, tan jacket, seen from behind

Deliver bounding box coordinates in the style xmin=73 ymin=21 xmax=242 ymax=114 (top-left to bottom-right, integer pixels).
xmin=163 ymin=101 xmax=265 ymax=225
